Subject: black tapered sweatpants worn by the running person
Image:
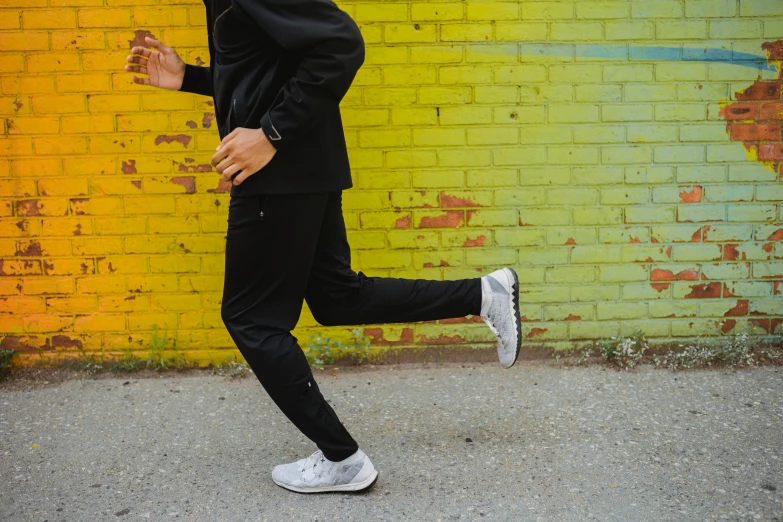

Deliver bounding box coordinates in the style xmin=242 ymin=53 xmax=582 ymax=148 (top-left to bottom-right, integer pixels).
xmin=221 ymin=192 xmax=481 ymax=461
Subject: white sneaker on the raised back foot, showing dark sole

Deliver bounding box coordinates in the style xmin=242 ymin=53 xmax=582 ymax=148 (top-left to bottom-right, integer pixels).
xmin=481 ymin=268 xmax=522 ymax=368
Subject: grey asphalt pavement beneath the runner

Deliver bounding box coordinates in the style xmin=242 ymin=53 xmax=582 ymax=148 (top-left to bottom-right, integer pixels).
xmin=0 ymin=361 xmax=783 ymax=522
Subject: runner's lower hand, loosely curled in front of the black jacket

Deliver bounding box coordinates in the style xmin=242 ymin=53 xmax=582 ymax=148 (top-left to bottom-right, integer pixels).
xmin=210 ymin=127 xmax=277 ymax=185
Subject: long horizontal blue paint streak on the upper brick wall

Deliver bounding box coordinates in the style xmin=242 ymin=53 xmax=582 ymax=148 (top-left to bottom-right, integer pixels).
xmin=519 ymin=42 xmax=777 ymax=72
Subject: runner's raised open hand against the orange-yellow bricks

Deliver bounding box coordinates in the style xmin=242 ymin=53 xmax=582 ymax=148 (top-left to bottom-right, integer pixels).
xmin=125 ymin=36 xmax=185 ymax=91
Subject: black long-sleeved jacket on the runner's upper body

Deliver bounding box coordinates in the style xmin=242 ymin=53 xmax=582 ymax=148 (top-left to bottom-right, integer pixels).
xmin=180 ymin=0 xmax=364 ymax=196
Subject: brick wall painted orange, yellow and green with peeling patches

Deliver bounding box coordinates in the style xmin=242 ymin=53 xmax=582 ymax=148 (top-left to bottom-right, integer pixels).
xmin=0 ymin=0 xmax=783 ymax=361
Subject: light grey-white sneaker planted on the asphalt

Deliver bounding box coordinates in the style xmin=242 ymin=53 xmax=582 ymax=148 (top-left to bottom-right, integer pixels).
xmin=272 ymin=450 xmax=378 ymax=493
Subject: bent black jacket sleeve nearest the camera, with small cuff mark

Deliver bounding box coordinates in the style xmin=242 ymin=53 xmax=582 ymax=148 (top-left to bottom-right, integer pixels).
xmin=234 ymin=0 xmax=364 ymax=150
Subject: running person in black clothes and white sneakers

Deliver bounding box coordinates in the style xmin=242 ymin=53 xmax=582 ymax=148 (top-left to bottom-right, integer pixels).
xmin=125 ymin=0 xmax=521 ymax=493
